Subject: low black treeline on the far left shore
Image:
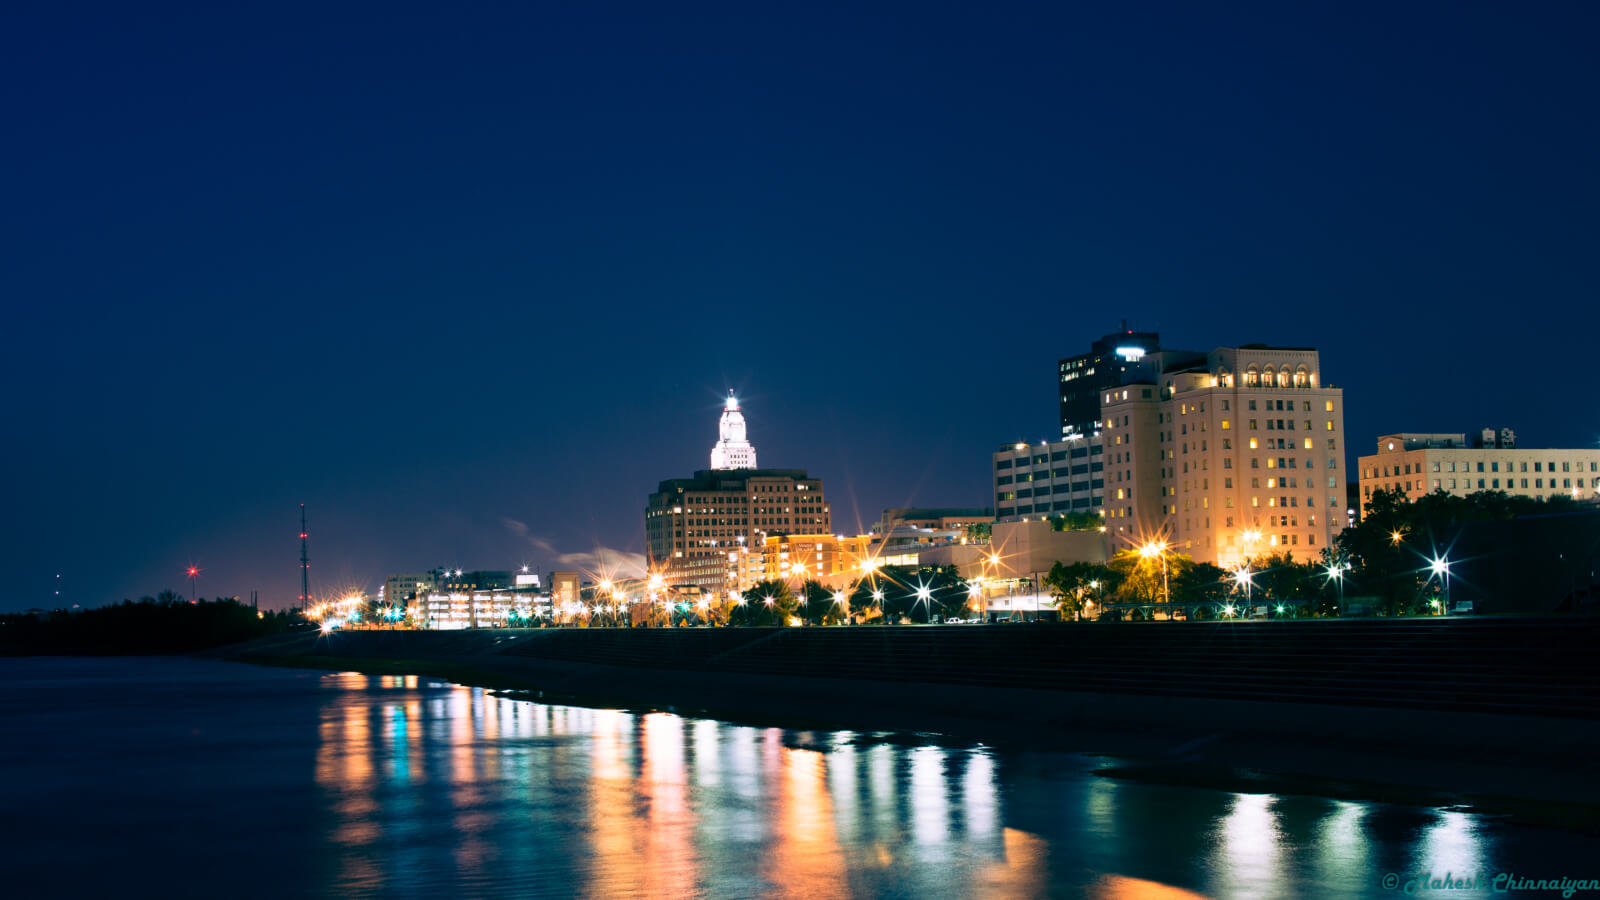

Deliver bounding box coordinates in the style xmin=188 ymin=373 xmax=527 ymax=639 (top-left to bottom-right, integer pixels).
xmin=0 ymin=593 xmax=304 ymax=657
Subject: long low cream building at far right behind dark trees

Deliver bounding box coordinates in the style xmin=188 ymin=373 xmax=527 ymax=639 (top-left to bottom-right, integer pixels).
xmin=1358 ymin=428 xmax=1600 ymax=509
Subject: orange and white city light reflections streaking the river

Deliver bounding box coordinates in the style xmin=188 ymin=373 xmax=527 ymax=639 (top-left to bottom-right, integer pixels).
xmin=300 ymin=674 xmax=1561 ymax=898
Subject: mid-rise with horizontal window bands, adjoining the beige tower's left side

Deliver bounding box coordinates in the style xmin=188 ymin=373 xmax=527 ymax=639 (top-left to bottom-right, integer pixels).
xmin=992 ymin=434 xmax=1106 ymax=522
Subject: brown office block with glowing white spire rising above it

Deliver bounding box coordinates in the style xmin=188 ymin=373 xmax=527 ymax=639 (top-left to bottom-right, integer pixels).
xmin=645 ymin=397 xmax=832 ymax=591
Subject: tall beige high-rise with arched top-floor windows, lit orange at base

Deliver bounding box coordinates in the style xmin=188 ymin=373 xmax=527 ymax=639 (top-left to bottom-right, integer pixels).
xmin=1101 ymin=344 xmax=1346 ymax=567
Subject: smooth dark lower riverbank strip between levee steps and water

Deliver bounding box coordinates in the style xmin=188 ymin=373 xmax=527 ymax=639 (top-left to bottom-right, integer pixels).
xmin=221 ymin=629 xmax=1600 ymax=831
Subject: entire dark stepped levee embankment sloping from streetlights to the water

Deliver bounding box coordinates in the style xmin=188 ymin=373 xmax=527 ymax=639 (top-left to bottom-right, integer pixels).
xmin=224 ymin=618 xmax=1600 ymax=822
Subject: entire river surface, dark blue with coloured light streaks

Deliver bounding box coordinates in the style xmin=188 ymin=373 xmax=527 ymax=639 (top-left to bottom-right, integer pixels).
xmin=0 ymin=660 xmax=1600 ymax=898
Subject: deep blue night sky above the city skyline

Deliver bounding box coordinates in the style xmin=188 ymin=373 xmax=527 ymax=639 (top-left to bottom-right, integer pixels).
xmin=0 ymin=3 xmax=1600 ymax=609
